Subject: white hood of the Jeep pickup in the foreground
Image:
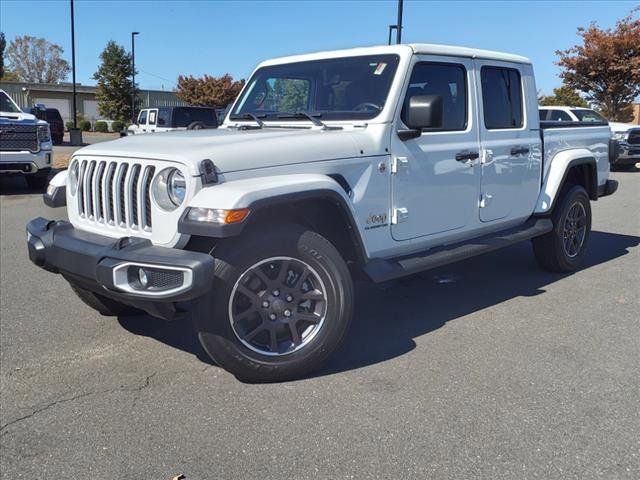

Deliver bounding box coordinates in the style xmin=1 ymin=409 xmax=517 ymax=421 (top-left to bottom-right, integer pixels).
xmin=77 ymin=126 xmax=384 ymax=173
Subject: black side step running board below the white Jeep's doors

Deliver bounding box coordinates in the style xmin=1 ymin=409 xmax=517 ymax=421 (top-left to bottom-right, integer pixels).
xmin=364 ymin=218 xmax=553 ymax=283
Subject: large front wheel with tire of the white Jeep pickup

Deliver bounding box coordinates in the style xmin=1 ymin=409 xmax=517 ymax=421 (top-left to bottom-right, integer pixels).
xmin=193 ymin=225 xmax=353 ymax=382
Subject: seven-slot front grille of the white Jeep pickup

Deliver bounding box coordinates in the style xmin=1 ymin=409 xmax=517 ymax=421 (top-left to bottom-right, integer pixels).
xmin=77 ymin=160 xmax=155 ymax=232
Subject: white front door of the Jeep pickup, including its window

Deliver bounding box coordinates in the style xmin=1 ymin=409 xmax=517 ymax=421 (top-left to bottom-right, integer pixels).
xmin=391 ymin=55 xmax=480 ymax=240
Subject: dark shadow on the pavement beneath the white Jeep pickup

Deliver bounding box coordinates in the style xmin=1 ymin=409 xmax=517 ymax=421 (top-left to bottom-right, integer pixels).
xmin=119 ymin=231 xmax=640 ymax=376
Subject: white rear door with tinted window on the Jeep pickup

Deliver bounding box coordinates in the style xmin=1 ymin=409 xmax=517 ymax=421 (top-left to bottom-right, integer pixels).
xmin=475 ymin=60 xmax=542 ymax=222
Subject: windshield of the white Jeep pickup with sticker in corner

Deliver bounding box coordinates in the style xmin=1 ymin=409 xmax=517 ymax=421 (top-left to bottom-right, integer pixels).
xmin=230 ymin=55 xmax=399 ymax=120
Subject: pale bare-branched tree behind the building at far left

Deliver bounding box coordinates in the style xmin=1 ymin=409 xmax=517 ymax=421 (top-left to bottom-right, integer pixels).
xmin=6 ymin=35 xmax=71 ymax=83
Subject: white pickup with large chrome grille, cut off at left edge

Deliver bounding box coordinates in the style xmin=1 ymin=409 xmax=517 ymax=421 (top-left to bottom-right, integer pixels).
xmin=0 ymin=90 xmax=53 ymax=188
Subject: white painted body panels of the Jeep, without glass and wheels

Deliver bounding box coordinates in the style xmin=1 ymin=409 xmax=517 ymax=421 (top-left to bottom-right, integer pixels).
xmin=62 ymin=44 xmax=610 ymax=259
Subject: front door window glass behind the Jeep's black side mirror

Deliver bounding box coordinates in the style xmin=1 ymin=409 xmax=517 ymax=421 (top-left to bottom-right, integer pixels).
xmin=401 ymin=63 xmax=467 ymax=130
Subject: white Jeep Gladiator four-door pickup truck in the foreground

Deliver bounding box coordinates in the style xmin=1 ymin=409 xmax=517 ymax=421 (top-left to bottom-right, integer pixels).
xmin=27 ymin=44 xmax=617 ymax=381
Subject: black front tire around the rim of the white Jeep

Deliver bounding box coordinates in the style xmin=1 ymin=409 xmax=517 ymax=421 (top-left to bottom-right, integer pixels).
xmin=192 ymin=225 xmax=353 ymax=382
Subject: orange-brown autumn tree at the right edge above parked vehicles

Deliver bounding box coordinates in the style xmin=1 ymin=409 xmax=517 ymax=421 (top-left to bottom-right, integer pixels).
xmin=556 ymin=8 xmax=640 ymax=121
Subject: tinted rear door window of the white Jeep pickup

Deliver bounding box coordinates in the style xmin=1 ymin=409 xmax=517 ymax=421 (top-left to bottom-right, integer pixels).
xmin=480 ymin=67 xmax=523 ymax=130
